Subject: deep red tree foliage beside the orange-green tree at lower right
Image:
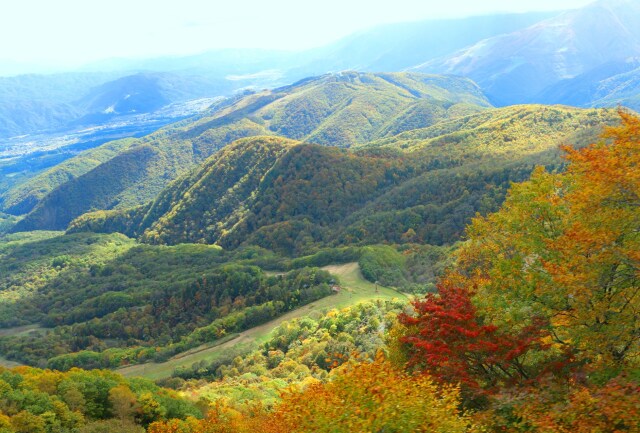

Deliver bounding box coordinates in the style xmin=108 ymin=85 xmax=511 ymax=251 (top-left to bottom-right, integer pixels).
xmin=399 ymin=284 xmax=545 ymax=390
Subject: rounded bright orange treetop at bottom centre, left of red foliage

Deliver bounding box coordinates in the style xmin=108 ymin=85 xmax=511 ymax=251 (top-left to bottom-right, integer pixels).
xmin=276 ymin=356 xmax=473 ymax=433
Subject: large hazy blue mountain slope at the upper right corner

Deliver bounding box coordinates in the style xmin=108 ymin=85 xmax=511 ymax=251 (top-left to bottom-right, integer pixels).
xmin=413 ymin=0 xmax=640 ymax=106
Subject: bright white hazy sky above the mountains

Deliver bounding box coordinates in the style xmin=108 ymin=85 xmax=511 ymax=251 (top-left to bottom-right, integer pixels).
xmin=0 ymin=0 xmax=592 ymax=65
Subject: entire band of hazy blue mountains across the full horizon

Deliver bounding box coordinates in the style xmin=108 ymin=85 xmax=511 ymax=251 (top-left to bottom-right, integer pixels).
xmin=5 ymin=0 xmax=640 ymax=139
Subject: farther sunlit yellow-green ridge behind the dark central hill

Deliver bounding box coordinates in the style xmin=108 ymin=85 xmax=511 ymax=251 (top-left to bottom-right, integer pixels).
xmin=4 ymin=73 xmax=490 ymax=230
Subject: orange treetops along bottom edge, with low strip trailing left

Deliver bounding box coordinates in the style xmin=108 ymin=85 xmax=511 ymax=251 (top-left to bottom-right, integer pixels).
xmin=148 ymin=356 xmax=476 ymax=433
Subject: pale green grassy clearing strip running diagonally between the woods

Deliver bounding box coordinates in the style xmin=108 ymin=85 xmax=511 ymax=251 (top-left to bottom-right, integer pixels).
xmin=117 ymin=263 xmax=406 ymax=379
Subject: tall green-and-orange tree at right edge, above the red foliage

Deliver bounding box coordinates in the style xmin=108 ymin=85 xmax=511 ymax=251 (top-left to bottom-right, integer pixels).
xmin=456 ymin=111 xmax=640 ymax=363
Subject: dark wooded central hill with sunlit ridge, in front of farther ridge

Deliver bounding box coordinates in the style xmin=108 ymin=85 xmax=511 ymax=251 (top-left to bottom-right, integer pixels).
xmin=69 ymin=106 xmax=617 ymax=255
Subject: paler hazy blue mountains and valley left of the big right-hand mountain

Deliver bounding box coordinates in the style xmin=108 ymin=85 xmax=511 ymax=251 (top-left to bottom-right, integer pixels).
xmin=0 ymin=13 xmax=549 ymax=139
